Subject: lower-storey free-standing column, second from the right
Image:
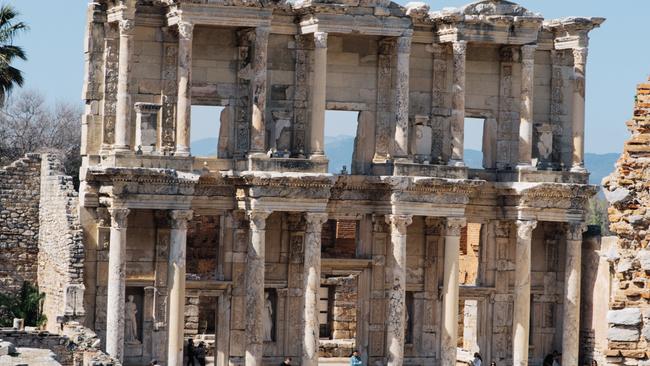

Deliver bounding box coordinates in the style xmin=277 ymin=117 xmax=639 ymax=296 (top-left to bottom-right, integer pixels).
xmin=512 ymin=220 xmax=537 ymax=366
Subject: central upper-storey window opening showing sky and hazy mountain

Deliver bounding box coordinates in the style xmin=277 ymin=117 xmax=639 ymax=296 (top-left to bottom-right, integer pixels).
xmin=325 ymin=110 xmax=359 ymax=174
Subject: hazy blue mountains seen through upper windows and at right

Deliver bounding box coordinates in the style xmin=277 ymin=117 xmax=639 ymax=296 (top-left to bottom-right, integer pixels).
xmin=192 ymin=136 xmax=620 ymax=185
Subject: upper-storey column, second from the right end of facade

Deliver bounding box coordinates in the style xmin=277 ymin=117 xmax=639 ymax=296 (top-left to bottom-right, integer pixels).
xmin=517 ymin=45 xmax=537 ymax=169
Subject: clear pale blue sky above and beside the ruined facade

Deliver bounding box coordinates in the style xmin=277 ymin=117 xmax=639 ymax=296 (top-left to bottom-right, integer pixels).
xmin=4 ymin=0 xmax=650 ymax=153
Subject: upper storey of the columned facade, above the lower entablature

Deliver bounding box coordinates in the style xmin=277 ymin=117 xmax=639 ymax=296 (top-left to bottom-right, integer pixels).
xmin=83 ymin=0 xmax=604 ymax=182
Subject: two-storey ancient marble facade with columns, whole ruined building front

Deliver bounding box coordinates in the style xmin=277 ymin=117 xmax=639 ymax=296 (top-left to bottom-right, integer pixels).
xmin=80 ymin=0 xmax=604 ymax=366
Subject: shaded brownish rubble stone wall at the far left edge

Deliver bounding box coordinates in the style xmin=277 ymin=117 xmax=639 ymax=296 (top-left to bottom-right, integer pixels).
xmin=0 ymin=154 xmax=41 ymax=293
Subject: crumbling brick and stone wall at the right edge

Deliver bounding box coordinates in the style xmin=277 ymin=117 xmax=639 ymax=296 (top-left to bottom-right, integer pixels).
xmin=603 ymin=83 xmax=650 ymax=365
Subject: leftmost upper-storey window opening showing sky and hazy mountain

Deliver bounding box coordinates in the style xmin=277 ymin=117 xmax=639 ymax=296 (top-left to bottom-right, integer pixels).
xmin=190 ymin=105 xmax=228 ymax=158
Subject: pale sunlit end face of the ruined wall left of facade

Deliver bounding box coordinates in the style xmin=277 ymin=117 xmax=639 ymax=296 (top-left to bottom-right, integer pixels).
xmin=38 ymin=154 xmax=85 ymax=332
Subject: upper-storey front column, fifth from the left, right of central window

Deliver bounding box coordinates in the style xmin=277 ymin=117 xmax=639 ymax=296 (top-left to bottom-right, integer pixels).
xmin=395 ymin=36 xmax=411 ymax=158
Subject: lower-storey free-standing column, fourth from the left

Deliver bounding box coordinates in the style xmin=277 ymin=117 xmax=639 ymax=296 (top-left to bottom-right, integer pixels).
xmin=301 ymin=213 xmax=327 ymax=366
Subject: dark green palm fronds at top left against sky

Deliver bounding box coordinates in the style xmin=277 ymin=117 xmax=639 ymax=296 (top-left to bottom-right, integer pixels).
xmin=0 ymin=4 xmax=27 ymax=105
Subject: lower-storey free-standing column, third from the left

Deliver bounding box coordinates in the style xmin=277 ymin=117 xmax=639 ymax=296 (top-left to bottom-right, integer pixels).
xmin=245 ymin=210 xmax=271 ymax=366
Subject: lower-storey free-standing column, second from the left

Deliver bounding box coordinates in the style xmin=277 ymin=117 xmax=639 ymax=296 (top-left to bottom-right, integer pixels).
xmin=167 ymin=210 xmax=192 ymax=366
